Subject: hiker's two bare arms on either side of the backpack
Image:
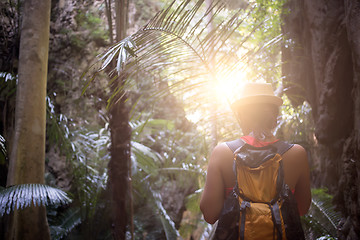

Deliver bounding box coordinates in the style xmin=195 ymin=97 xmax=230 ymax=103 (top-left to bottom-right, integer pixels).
xmin=200 ymin=139 xmax=311 ymax=222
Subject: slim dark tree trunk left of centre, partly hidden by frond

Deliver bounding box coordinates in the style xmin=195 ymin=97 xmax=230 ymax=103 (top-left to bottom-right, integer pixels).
xmin=108 ymin=0 xmax=131 ymax=239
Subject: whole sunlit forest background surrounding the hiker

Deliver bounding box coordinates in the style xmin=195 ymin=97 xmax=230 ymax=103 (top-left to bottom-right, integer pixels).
xmin=0 ymin=0 xmax=360 ymax=239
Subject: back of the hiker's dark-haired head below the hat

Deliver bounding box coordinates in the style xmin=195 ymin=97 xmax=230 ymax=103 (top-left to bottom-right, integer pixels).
xmin=237 ymin=104 xmax=279 ymax=140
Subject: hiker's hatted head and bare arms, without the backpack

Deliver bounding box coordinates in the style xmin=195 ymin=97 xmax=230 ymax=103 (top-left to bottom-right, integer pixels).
xmin=200 ymin=83 xmax=311 ymax=227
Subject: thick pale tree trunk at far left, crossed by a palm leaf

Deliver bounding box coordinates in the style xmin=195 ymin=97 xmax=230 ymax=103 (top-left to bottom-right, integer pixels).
xmin=7 ymin=0 xmax=51 ymax=240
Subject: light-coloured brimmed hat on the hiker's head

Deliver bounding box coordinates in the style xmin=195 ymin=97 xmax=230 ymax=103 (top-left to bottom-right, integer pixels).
xmin=231 ymin=83 xmax=283 ymax=110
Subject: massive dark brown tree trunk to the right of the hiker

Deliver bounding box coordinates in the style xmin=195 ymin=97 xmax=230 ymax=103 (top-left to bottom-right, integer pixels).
xmin=282 ymin=0 xmax=360 ymax=239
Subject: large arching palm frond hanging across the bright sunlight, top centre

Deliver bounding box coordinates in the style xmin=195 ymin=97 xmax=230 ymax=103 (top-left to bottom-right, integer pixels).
xmin=83 ymin=0 xmax=281 ymax=120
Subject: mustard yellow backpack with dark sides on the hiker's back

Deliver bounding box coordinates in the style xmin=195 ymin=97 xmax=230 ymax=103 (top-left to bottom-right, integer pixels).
xmin=214 ymin=139 xmax=305 ymax=240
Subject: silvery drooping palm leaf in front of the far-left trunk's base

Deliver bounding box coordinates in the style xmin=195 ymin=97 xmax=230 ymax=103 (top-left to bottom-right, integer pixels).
xmin=0 ymin=184 xmax=71 ymax=216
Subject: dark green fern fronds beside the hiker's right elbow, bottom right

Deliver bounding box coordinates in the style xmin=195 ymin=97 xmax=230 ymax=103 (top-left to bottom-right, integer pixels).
xmin=302 ymin=188 xmax=341 ymax=239
